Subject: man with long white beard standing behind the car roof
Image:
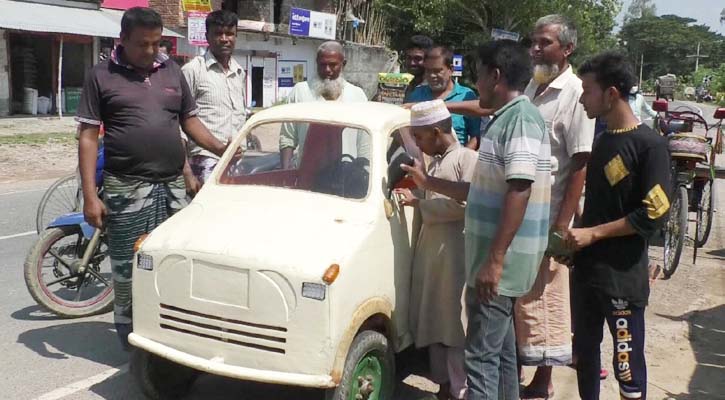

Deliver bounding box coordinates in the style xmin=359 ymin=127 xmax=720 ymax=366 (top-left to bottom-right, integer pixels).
xmin=279 ymin=41 xmax=369 ymax=169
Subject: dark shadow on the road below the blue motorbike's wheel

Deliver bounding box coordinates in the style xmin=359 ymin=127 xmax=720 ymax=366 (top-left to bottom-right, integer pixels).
xmin=18 ymin=321 xmax=128 ymax=367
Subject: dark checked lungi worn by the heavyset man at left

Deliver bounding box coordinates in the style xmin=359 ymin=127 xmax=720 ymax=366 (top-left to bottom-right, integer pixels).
xmin=103 ymin=173 xmax=187 ymax=325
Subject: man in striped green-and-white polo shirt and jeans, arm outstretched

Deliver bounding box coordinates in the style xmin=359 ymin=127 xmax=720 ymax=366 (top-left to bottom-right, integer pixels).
xmin=403 ymin=40 xmax=551 ymax=400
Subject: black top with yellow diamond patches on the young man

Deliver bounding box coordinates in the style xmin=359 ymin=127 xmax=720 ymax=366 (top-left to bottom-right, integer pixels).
xmin=573 ymin=125 xmax=671 ymax=306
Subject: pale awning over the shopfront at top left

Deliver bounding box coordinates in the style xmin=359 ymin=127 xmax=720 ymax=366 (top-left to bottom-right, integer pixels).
xmin=0 ymin=0 xmax=183 ymax=38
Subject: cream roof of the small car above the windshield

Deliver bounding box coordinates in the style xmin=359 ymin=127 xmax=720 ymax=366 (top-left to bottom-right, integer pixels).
xmin=248 ymin=101 xmax=410 ymax=134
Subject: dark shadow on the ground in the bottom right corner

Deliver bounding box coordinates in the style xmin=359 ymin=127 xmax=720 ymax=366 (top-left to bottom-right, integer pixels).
xmin=658 ymin=304 xmax=725 ymax=400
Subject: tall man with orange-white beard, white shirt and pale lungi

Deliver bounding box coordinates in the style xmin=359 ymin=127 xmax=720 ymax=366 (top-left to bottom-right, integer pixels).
xmin=515 ymin=15 xmax=594 ymax=399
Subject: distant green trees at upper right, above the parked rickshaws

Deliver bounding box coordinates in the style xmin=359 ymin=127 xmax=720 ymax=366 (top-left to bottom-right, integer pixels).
xmin=619 ymin=15 xmax=725 ymax=79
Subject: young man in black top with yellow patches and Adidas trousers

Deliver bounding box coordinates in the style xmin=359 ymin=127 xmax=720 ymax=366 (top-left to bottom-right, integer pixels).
xmin=567 ymin=53 xmax=671 ymax=400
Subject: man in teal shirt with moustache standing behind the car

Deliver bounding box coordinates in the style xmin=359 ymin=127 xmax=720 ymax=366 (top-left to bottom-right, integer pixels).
xmin=408 ymin=46 xmax=481 ymax=150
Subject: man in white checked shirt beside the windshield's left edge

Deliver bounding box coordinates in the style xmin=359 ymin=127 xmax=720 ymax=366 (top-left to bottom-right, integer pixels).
xmin=182 ymin=10 xmax=246 ymax=184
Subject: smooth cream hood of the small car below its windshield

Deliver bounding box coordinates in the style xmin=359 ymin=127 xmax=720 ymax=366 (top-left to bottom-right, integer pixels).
xmin=143 ymin=186 xmax=374 ymax=267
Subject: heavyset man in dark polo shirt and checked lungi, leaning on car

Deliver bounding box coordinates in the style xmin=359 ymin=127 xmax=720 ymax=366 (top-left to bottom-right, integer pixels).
xmin=76 ymin=7 xmax=226 ymax=348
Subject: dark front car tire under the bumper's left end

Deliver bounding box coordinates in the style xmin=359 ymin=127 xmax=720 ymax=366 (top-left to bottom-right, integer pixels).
xmin=130 ymin=348 xmax=200 ymax=400
